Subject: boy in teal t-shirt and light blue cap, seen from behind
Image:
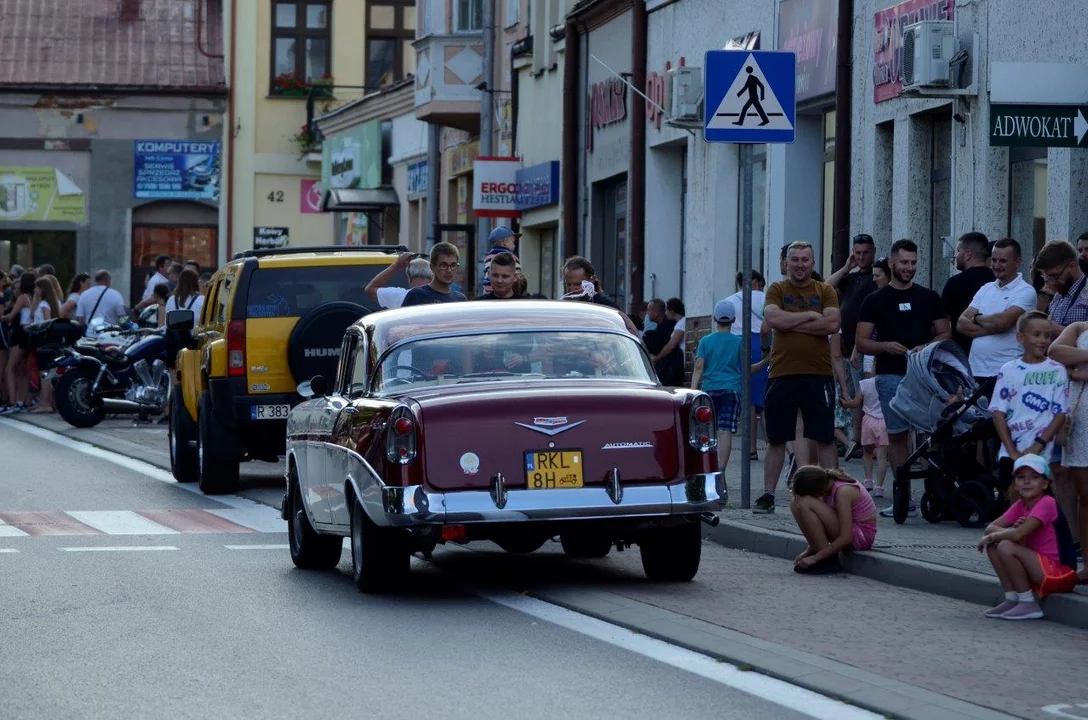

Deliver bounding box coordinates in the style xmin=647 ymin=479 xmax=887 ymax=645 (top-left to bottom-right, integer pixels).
xmin=691 ymin=299 xmax=747 ymax=470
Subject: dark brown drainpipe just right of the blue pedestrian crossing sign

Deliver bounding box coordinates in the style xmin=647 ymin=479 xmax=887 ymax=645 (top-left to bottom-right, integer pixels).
xmin=828 ymin=0 xmax=854 ymax=271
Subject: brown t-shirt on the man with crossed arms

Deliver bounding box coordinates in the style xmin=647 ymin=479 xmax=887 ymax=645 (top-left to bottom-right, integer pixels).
xmin=765 ymin=280 xmax=839 ymax=377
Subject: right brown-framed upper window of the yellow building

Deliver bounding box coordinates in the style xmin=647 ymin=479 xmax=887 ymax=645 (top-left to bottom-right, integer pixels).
xmin=367 ymin=0 xmax=416 ymax=89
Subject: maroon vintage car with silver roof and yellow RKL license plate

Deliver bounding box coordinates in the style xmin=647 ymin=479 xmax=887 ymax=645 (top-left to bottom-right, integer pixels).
xmin=283 ymin=300 xmax=726 ymax=592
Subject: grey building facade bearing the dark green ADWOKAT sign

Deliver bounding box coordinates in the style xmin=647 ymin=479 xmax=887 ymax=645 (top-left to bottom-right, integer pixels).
xmin=851 ymin=0 xmax=1088 ymax=289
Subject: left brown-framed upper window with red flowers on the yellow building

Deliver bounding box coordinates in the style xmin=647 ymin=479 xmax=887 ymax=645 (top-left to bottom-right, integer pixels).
xmin=270 ymin=0 xmax=332 ymax=96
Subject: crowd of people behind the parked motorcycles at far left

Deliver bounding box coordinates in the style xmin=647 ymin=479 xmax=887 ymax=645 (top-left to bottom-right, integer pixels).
xmin=0 ymin=255 xmax=211 ymax=414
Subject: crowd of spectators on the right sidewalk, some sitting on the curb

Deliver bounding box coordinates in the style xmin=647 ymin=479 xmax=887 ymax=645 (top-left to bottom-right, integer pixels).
xmin=692 ymin=233 xmax=1088 ymax=620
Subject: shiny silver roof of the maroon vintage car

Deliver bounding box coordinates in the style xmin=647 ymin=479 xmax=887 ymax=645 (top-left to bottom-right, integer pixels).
xmin=367 ymin=300 xmax=628 ymax=348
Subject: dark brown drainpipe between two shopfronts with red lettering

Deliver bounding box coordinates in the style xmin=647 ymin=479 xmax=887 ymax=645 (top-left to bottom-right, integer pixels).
xmin=623 ymin=1 xmax=647 ymax=312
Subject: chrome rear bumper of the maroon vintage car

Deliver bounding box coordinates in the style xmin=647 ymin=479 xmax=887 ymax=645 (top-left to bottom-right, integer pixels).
xmin=360 ymin=472 xmax=728 ymax=526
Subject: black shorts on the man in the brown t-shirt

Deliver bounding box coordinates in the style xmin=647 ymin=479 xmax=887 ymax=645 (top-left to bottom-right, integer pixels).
xmin=764 ymin=375 xmax=837 ymax=445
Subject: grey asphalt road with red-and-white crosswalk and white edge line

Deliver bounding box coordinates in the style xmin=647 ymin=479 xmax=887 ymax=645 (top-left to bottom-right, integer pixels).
xmin=0 ymin=424 xmax=864 ymax=719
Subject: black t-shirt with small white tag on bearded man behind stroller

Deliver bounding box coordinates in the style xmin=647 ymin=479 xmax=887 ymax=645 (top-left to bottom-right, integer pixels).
xmin=857 ymin=285 xmax=948 ymax=375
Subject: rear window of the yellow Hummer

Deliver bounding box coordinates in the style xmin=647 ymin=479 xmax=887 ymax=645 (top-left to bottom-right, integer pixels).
xmin=246 ymin=264 xmax=408 ymax=318
